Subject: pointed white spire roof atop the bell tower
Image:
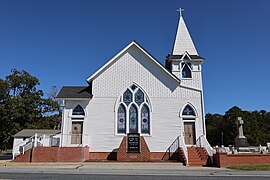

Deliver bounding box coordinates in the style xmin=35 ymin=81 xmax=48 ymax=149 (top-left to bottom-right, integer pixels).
xmin=172 ymin=10 xmax=198 ymax=55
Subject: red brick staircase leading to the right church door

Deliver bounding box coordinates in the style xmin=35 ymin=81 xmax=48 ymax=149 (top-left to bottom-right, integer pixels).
xmin=180 ymin=147 xmax=208 ymax=166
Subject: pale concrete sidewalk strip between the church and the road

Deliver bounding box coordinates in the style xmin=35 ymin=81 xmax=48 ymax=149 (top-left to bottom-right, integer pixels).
xmin=0 ymin=161 xmax=270 ymax=177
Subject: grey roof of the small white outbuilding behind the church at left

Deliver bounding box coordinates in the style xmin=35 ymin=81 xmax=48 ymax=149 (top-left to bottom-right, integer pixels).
xmin=14 ymin=129 xmax=61 ymax=138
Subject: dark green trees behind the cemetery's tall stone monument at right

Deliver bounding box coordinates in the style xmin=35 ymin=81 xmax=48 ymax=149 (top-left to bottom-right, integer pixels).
xmin=206 ymin=106 xmax=270 ymax=146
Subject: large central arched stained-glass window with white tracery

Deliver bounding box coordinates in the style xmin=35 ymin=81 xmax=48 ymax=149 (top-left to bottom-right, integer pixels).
xmin=117 ymin=84 xmax=150 ymax=134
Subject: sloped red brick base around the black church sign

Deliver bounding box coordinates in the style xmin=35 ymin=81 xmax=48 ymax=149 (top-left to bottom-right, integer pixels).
xmin=117 ymin=137 xmax=150 ymax=162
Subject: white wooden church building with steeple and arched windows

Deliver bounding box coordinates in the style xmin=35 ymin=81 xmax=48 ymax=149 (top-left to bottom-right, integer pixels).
xmin=54 ymin=10 xmax=211 ymax=164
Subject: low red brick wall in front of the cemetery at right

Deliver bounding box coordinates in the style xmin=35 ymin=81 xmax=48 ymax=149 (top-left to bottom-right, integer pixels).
xmin=214 ymin=152 xmax=270 ymax=167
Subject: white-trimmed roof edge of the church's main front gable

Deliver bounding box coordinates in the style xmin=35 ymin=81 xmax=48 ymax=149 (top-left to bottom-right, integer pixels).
xmin=87 ymin=41 xmax=180 ymax=82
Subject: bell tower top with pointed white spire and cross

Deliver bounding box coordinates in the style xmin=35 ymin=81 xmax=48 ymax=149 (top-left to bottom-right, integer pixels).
xmin=166 ymin=8 xmax=204 ymax=89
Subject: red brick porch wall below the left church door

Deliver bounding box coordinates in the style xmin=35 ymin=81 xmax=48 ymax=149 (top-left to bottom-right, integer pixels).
xmin=14 ymin=147 xmax=89 ymax=162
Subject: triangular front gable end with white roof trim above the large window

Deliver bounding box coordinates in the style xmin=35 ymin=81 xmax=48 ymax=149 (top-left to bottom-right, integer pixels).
xmin=88 ymin=42 xmax=179 ymax=97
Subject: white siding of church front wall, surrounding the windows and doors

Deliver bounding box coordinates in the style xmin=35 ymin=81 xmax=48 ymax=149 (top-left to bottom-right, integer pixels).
xmin=62 ymin=46 xmax=203 ymax=152
